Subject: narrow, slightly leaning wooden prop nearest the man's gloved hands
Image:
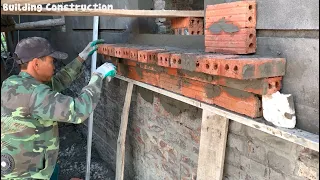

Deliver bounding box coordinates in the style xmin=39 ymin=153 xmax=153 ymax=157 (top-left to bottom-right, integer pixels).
xmin=116 ymin=82 xmax=133 ymax=180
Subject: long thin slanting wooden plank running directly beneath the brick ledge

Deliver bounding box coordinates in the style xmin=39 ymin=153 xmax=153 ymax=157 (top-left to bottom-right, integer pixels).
xmin=116 ymin=75 xmax=319 ymax=152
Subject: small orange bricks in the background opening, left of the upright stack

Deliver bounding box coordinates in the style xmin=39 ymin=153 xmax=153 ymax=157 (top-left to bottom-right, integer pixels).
xmin=171 ymin=17 xmax=204 ymax=35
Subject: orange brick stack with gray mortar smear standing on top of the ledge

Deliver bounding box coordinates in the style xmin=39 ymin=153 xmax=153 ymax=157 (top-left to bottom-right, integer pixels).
xmin=205 ymin=1 xmax=257 ymax=54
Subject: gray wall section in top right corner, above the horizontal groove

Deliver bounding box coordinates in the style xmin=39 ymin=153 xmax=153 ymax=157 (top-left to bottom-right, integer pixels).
xmin=204 ymin=0 xmax=319 ymax=30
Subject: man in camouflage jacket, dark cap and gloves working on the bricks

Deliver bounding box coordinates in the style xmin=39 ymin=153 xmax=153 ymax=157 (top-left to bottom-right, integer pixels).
xmin=1 ymin=37 xmax=116 ymax=180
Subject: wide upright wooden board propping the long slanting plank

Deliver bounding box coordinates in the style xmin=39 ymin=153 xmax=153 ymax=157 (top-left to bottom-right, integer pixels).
xmin=197 ymin=110 xmax=229 ymax=180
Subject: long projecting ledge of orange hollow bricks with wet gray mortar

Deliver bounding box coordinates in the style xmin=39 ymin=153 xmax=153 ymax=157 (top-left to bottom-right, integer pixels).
xmin=98 ymin=44 xmax=286 ymax=118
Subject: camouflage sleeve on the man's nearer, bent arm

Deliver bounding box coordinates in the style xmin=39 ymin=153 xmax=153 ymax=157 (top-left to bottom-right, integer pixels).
xmin=30 ymin=75 xmax=103 ymax=124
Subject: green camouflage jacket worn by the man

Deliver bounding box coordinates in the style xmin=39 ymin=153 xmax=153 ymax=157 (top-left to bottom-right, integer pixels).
xmin=1 ymin=59 xmax=103 ymax=179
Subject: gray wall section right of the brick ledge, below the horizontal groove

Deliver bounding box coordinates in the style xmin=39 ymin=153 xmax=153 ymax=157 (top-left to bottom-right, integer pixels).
xmin=257 ymin=37 xmax=319 ymax=134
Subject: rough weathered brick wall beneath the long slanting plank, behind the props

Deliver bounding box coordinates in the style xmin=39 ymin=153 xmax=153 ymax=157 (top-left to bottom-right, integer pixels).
xmin=89 ymin=79 xmax=319 ymax=180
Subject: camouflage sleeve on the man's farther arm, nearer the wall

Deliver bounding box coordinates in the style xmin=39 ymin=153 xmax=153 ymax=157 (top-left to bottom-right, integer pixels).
xmin=47 ymin=58 xmax=84 ymax=92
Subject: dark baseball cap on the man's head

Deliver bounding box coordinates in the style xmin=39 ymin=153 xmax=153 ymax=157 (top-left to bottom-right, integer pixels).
xmin=14 ymin=37 xmax=68 ymax=64
